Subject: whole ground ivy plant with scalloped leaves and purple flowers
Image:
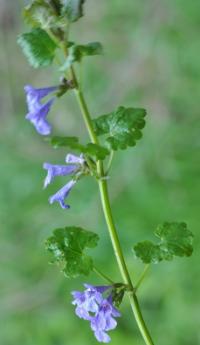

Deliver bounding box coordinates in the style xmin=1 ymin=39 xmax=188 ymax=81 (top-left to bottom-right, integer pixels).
xmin=18 ymin=0 xmax=193 ymax=345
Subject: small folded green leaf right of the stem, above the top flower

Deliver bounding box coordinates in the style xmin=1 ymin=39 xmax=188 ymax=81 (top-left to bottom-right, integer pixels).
xmin=60 ymin=42 xmax=103 ymax=71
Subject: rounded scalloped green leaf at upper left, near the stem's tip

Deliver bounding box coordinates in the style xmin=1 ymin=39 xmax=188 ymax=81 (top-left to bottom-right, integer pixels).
xmin=18 ymin=28 xmax=56 ymax=68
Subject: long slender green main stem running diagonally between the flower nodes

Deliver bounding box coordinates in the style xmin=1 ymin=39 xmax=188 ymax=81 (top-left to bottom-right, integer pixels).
xmin=75 ymin=81 xmax=154 ymax=345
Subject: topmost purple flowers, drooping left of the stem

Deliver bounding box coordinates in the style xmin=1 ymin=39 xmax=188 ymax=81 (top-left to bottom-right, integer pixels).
xmin=24 ymin=85 xmax=58 ymax=135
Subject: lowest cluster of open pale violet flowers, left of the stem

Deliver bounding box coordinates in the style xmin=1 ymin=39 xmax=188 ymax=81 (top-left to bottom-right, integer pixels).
xmin=72 ymin=284 xmax=120 ymax=343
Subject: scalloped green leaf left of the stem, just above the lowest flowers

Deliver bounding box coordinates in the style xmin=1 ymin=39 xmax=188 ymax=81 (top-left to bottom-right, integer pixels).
xmin=46 ymin=227 xmax=99 ymax=278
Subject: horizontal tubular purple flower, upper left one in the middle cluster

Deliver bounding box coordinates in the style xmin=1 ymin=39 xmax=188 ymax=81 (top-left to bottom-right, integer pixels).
xmin=43 ymin=163 xmax=78 ymax=188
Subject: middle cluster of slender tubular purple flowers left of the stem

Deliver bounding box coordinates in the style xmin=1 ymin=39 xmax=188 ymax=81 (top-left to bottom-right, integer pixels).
xmin=43 ymin=154 xmax=85 ymax=209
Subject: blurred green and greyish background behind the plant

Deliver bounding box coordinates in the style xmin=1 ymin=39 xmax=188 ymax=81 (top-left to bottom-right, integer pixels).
xmin=0 ymin=0 xmax=200 ymax=345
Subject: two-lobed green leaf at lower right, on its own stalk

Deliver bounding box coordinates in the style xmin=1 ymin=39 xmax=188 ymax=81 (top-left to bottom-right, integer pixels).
xmin=133 ymin=222 xmax=193 ymax=264
